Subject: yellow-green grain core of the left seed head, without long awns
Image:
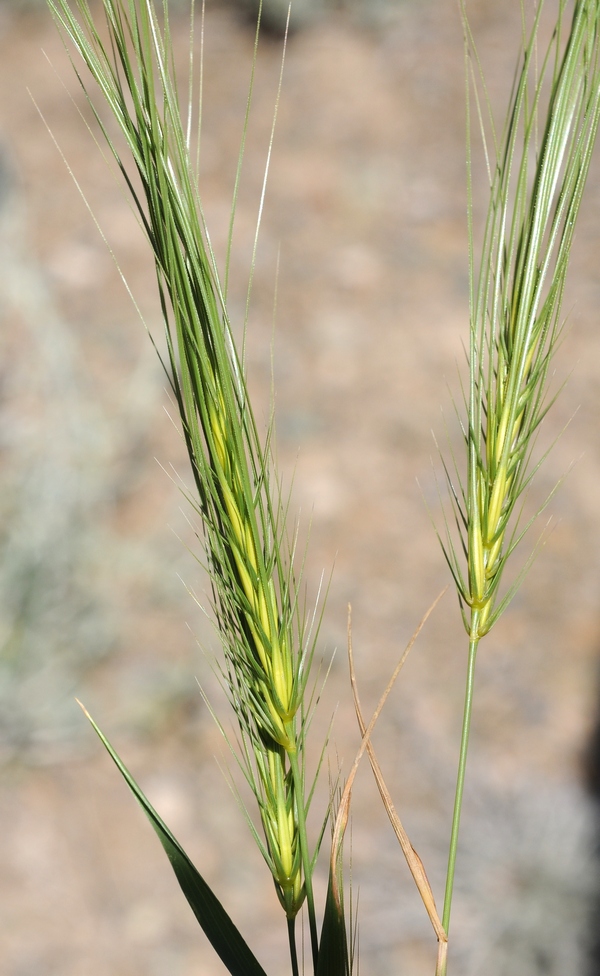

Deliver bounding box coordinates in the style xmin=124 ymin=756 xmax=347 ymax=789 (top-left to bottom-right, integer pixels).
xmin=206 ymin=368 xmax=312 ymax=919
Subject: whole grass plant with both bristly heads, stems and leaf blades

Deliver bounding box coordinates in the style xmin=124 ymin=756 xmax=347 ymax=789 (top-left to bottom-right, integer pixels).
xmin=48 ymin=0 xmax=600 ymax=976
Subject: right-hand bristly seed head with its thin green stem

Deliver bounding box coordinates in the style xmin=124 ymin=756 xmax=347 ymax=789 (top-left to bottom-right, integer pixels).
xmin=436 ymin=0 xmax=600 ymax=976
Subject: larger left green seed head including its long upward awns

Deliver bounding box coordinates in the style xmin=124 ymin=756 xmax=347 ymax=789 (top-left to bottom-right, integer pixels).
xmin=49 ymin=0 xmax=326 ymax=959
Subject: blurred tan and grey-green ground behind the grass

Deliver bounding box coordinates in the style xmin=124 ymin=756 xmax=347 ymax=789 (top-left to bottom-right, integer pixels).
xmin=0 ymin=0 xmax=600 ymax=976
